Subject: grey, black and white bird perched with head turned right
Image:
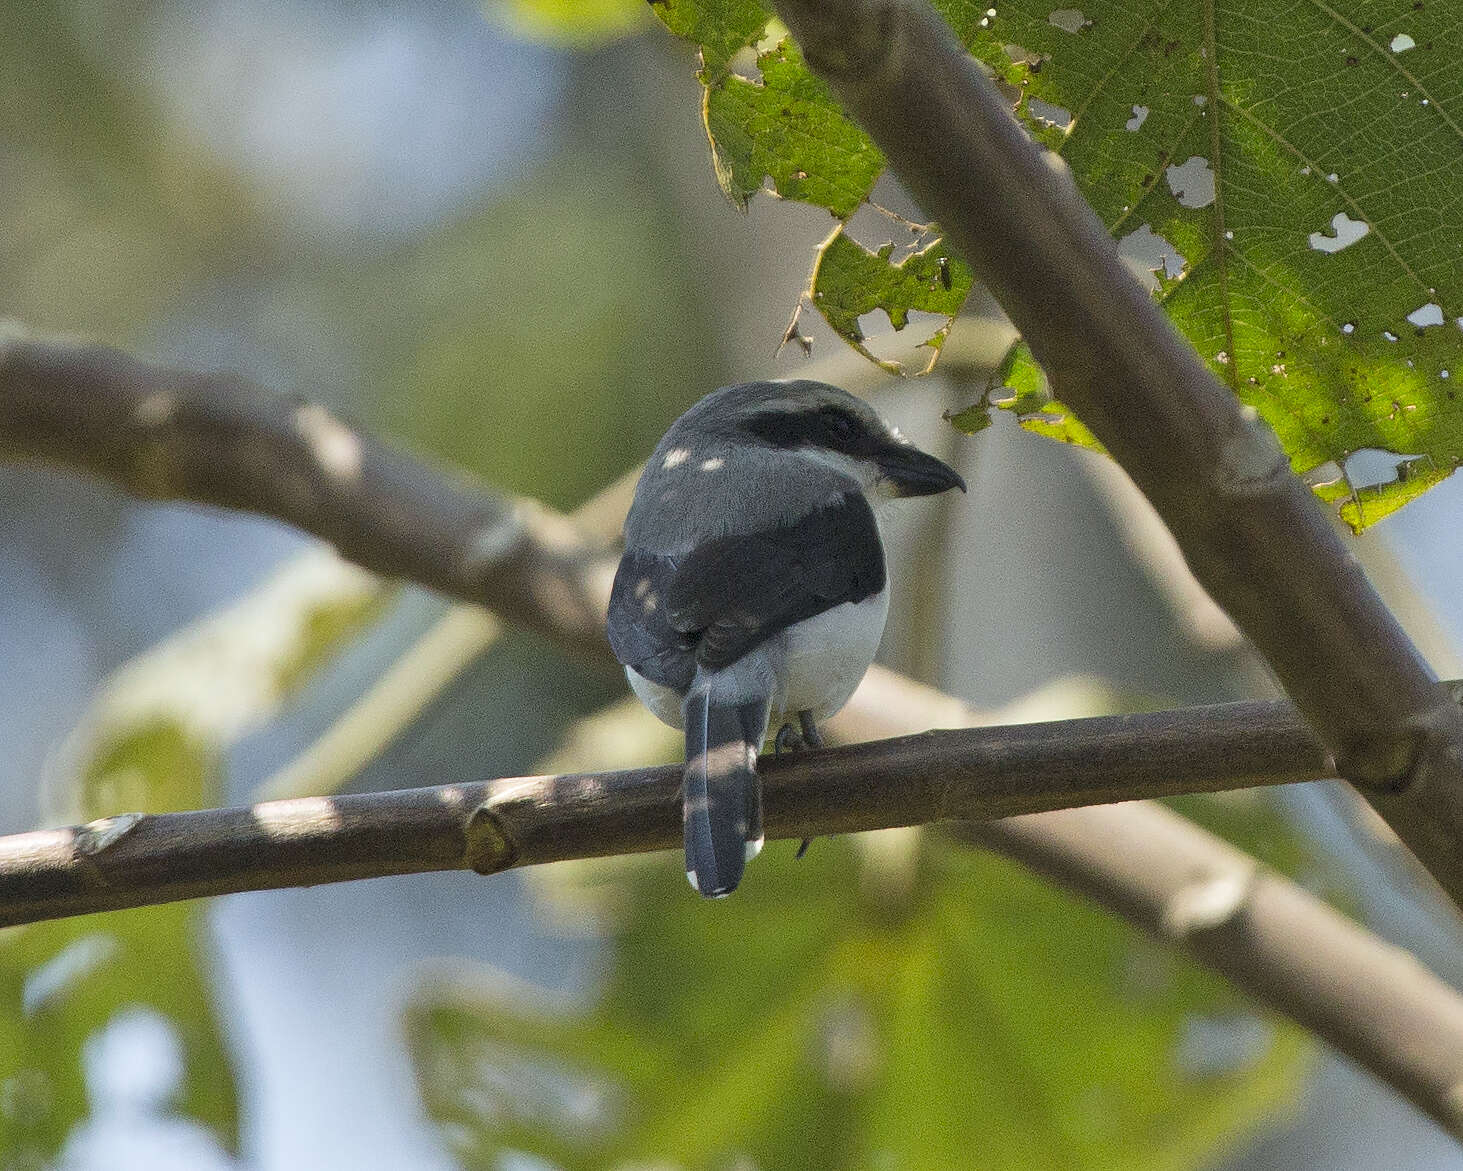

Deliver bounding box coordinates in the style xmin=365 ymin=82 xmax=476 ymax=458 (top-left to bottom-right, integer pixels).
xmin=607 ymin=379 xmax=966 ymax=897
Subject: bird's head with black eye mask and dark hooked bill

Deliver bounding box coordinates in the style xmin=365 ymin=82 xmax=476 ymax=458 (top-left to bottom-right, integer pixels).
xmin=667 ymin=379 xmax=966 ymax=496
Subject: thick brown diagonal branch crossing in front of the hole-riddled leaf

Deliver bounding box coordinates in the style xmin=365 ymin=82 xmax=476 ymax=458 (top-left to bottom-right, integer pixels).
xmin=777 ymin=0 xmax=1463 ymax=903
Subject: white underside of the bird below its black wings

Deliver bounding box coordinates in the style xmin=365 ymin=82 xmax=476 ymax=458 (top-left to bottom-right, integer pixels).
xmin=625 ymin=588 xmax=890 ymax=727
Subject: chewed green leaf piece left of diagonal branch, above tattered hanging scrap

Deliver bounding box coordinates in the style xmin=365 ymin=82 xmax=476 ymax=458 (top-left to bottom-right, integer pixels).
xmin=705 ymin=40 xmax=884 ymax=220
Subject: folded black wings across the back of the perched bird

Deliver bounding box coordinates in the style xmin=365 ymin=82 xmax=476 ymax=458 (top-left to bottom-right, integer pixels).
xmin=610 ymin=492 xmax=885 ymax=691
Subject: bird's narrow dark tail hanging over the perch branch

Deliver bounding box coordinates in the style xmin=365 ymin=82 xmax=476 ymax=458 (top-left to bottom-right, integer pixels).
xmin=683 ymin=688 xmax=768 ymax=899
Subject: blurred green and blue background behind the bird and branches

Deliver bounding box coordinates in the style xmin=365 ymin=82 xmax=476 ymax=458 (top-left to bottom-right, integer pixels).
xmin=0 ymin=0 xmax=1463 ymax=1171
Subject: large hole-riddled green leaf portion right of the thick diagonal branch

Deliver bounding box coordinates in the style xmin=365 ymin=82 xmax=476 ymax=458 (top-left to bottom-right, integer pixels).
xmin=960 ymin=0 xmax=1463 ymax=528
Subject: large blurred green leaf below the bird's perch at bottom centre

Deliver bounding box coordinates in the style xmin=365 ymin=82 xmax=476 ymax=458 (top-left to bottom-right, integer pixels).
xmin=407 ymin=839 xmax=1309 ymax=1171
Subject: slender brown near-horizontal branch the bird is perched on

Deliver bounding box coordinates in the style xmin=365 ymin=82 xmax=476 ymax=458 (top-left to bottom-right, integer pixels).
xmin=0 ymin=703 xmax=1330 ymax=927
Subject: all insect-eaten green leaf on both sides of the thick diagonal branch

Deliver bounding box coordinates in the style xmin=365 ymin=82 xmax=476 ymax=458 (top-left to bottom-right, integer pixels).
xmin=654 ymin=0 xmax=1463 ymax=530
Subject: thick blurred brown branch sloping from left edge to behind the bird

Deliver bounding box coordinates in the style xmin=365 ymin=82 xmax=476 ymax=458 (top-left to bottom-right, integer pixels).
xmin=0 ymin=322 xmax=617 ymax=656
